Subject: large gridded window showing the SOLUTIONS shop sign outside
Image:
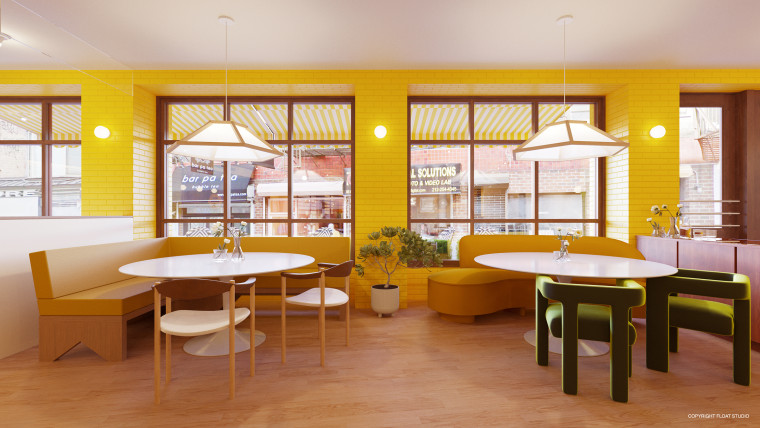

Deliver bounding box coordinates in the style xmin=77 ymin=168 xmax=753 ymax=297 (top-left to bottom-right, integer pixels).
xmin=409 ymin=97 xmax=604 ymax=258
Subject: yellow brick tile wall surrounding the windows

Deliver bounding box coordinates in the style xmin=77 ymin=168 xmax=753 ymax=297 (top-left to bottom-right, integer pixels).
xmin=5 ymin=69 xmax=760 ymax=307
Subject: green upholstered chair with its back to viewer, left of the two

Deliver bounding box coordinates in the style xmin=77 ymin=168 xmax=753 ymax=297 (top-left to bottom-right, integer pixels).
xmin=536 ymin=275 xmax=645 ymax=403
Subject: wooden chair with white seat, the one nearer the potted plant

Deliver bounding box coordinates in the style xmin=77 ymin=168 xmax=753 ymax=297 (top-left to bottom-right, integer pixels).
xmin=280 ymin=260 xmax=354 ymax=367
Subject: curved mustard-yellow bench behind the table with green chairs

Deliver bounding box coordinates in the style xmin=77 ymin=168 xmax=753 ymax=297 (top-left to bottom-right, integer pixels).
xmin=428 ymin=235 xmax=644 ymax=323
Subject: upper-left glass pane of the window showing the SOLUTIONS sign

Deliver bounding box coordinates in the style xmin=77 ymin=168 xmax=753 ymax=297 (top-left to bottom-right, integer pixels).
xmin=411 ymin=104 xmax=470 ymax=140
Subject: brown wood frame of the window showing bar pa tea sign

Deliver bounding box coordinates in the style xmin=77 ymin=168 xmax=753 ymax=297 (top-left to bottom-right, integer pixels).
xmin=156 ymin=96 xmax=356 ymax=247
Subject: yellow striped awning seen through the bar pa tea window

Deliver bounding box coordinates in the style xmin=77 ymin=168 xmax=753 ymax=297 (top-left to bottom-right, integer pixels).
xmin=169 ymin=103 xmax=351 ymax=140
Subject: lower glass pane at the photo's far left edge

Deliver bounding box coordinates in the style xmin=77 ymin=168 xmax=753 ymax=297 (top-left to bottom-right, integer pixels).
xmin=0 ymin=144 xmax=42 ymax=217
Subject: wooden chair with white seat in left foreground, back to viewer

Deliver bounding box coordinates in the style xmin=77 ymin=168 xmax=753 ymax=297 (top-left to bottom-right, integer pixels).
xmin=153 ymin=279 xmax=255 ymax=404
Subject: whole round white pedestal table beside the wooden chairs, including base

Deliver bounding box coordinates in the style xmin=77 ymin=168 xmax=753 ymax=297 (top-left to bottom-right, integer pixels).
xmin=119 ymin=252 xmax=314 ymax=356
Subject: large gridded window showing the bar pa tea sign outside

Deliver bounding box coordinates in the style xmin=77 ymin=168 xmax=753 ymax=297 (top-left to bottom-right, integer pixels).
xmin=158 ymin=97 xmax=354 ymax=244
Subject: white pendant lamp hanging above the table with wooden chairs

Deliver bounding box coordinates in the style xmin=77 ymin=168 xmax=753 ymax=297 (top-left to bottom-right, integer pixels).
xmin=167 ymin=16 xmax=282 ymax=162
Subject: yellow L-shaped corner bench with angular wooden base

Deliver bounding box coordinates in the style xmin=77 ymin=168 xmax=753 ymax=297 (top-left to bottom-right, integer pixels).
xmin=29 ymin=237 xmax=351 ymax=361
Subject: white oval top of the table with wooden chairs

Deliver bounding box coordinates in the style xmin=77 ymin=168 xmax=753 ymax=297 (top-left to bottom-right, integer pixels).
xmin=119 ymin=252 xmax=314 ymax=278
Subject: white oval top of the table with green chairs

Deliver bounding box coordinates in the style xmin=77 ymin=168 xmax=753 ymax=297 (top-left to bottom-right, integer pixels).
xmin=475 ymin=253 xmax=678 ymax=279
